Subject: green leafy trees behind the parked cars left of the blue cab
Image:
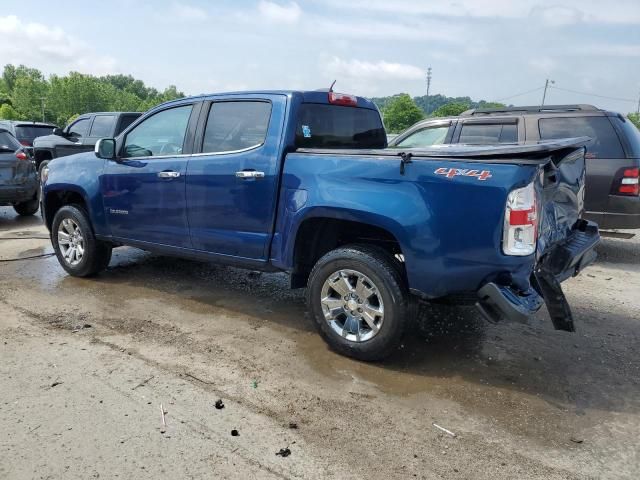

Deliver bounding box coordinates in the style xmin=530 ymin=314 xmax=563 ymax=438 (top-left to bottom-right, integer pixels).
xmin=0 ymin=65 xmax=184 ymax=126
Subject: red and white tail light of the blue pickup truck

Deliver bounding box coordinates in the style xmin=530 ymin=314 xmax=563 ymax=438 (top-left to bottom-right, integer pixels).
xmin=502 ymin=183 xmax=538 ymax=256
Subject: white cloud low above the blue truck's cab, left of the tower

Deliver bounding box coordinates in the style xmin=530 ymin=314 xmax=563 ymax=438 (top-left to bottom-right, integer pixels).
xmin=325 ymin=57 xmax=425 ymax=81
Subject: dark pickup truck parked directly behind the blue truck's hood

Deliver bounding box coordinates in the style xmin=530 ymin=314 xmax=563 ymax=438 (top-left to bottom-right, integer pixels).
xmin=33 ymin=112 xmax=142 ymax=175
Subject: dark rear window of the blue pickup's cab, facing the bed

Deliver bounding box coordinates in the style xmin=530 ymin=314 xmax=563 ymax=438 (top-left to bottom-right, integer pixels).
xmin=296 ymin=103 xmax=387 ymax=148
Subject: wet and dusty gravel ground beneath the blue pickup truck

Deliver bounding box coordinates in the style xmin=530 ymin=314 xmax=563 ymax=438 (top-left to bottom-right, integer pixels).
xmin=0 ymin=208 xmax=640 ymax=480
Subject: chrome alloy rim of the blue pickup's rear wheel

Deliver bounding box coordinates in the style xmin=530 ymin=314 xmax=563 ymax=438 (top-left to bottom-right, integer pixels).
xmin=320 ymin=270 xmax=384 ymax=342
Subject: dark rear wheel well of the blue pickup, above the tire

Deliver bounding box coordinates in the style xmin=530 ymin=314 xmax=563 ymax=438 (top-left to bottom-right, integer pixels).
xmin=291 ymin=218 xmax=405 ymax=288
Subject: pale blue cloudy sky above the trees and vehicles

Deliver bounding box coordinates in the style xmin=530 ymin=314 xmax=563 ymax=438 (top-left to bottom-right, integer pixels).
xmin=0 ymin=0 xmax=640 ymax=112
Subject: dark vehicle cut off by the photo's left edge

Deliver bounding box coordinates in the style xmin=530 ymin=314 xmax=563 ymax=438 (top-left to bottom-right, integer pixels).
xmin=0 ymin=129 xmax=39 ymax=215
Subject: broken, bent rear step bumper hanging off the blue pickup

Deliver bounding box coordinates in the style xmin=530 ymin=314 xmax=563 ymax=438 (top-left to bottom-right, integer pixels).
xmin=476 ymin=220 xmax=600 ymax=332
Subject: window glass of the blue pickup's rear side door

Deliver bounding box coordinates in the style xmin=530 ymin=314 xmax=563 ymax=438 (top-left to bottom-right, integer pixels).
xmin=202 ymin=101 xmax=271 ymax=153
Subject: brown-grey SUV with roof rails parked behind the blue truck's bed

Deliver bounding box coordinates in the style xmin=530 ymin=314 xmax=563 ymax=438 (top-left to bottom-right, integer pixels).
xmin=390 ymin=105 xmax=640 ymax=229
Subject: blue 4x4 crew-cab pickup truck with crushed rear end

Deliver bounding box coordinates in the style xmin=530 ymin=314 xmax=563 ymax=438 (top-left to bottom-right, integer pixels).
xmin=42 ymin=90 xmax=599 ymax=360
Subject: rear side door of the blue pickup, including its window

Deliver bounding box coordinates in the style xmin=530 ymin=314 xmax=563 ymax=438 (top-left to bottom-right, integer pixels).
xmin=187 ymin=95 xmax=286 ymax=260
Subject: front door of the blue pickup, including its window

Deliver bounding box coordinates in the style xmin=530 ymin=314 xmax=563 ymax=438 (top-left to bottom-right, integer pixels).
xmin=101 ymin=104 xmax=199 ymax=248
